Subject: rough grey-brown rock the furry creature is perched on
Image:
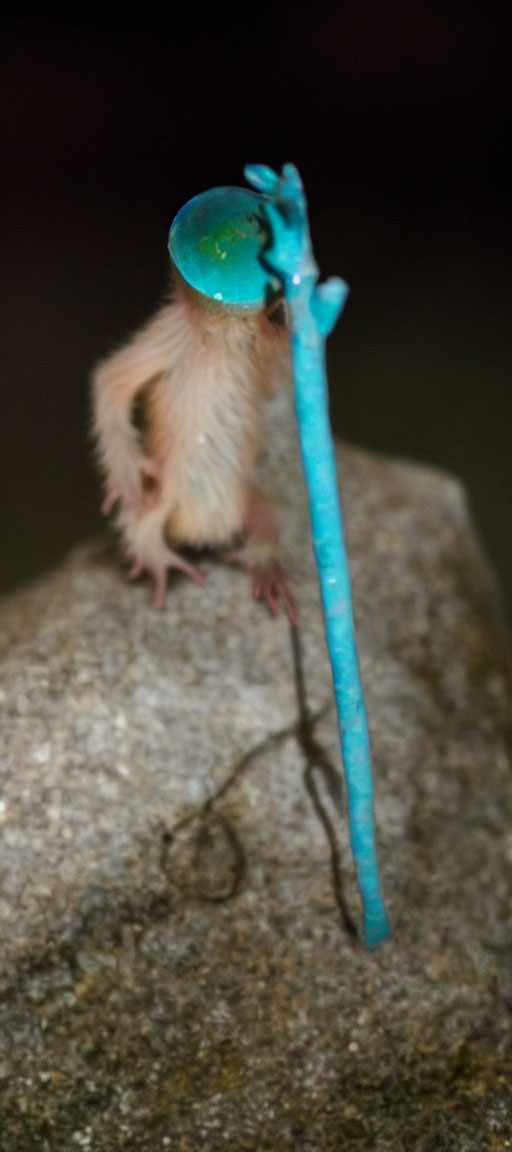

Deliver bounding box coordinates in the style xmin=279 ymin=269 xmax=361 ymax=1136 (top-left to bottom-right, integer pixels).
xmin=0 ymin=397 xmax=512 ymax=1152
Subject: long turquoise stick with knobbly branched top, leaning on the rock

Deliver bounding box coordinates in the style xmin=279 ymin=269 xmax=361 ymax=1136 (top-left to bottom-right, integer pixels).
xmin=244 ymin=164 xmax=389 ymax=948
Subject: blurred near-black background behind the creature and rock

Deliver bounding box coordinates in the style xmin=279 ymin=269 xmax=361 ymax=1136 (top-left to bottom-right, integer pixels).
xmin=0 ymin=0 xmax=512 ymax=631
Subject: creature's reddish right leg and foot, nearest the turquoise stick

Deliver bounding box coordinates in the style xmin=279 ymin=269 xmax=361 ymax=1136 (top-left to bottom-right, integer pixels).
xmin=228 ymin=488 xmax=296 ymax=626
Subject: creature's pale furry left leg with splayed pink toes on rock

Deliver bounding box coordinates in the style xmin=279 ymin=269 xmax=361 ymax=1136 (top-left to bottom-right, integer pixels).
xmin=118 ymin=500 xmax=206 ymax=608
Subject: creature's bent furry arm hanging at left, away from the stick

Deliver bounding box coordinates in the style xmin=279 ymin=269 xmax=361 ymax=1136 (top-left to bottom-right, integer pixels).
xmin=93 ymin=304 xmax=173 ymax=515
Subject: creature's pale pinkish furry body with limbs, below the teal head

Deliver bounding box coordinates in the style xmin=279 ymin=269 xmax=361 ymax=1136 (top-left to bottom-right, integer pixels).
xmin=93 ymin=276 xmax=293 ymax=617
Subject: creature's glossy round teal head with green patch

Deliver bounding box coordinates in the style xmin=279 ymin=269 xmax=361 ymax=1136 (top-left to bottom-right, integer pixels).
xmin=168 ymin=188 xmax=283 ymax=311
